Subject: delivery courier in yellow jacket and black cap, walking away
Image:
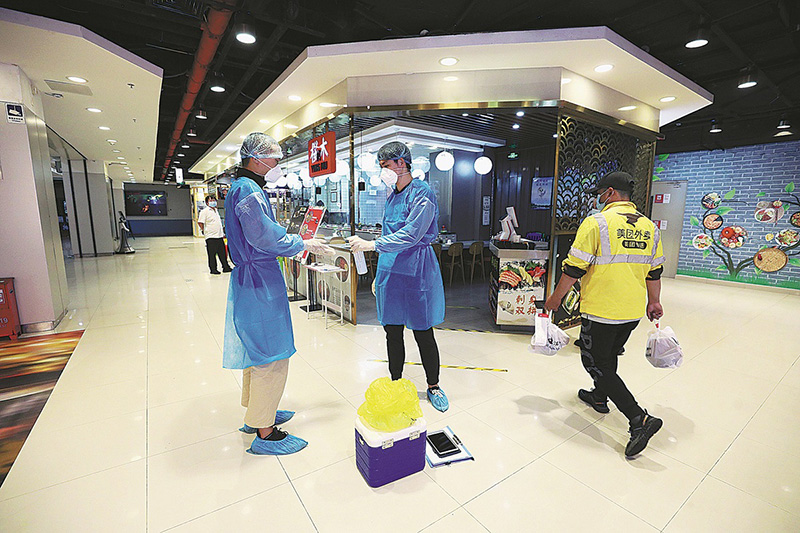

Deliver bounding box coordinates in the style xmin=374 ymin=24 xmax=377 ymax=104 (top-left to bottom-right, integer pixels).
xmin=545 ymin=172 xmax=664 ymax=457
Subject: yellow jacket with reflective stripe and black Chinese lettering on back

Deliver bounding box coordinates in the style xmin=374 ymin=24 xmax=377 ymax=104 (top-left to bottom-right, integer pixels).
xmin=564 ymin=202 xmax=664 ymax=320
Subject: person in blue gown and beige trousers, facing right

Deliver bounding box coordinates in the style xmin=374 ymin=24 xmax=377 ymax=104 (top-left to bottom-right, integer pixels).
xmin=223 ymin=133 xmax=333 ymax=455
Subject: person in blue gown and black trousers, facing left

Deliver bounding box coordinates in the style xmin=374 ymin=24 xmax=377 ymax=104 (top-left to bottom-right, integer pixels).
xmin=348 ymin=142 xmax=449 ymax=411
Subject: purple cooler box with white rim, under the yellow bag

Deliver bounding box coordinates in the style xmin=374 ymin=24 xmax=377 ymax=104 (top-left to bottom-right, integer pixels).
xmin=356 ymin=417 xmax=427 ymax=487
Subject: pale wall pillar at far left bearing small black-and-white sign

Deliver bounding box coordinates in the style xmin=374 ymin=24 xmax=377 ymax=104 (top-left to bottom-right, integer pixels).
xmin=0 ymin=64 xmax=68 ymax=331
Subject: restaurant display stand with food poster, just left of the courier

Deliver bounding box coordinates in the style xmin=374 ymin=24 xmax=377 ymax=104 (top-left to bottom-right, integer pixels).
xmin=489 ymin=241 xmax=550 ymax=331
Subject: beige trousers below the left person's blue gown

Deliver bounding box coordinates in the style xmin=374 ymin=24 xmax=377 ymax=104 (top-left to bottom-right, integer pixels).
xmin=242 ymin=358 xmax=289 ymax=428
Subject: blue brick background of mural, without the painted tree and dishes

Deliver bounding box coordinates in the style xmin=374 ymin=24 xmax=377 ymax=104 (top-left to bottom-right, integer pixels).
xmin=655 ymin=141 xmax=800 ymax=289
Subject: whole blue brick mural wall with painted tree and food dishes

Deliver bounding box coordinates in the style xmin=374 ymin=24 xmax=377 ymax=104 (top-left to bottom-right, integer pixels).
xmin=655 ymin=137 xmax=800 ymax=289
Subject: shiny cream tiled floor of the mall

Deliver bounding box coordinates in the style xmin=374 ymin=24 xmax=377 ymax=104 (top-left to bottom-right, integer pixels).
xmin=0 ymin=238 xmax=800 ymax=533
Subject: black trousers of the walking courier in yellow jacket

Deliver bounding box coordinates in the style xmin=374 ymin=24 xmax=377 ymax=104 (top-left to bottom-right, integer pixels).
xmin=580 ymin=318 xmax=644 ymax=420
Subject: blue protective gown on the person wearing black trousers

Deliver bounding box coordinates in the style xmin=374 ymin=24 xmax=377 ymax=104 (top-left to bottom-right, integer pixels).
xmin=375 ymin=179 xmax=444 ymax=330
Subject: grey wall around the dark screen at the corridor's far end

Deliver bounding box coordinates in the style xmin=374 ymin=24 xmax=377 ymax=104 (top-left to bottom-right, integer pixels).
xmin=125 ymin=183 xmax=192 ymax=236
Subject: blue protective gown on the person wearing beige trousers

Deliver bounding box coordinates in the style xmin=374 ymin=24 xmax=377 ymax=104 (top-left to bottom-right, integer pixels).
xmin=222 ymin=177 xmax=303 ymax=368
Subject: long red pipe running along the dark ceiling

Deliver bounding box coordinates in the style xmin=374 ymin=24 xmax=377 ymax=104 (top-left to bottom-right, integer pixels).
xmin=161 ymin=0 xmax=236 ymax=180
